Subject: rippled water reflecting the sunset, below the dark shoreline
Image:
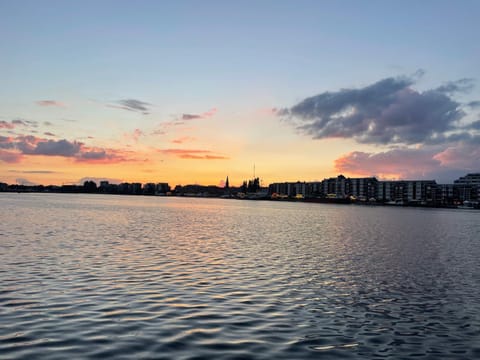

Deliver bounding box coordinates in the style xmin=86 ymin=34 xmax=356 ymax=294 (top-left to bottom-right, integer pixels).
xmin=0 ymin=194 xmax=480 ymax=359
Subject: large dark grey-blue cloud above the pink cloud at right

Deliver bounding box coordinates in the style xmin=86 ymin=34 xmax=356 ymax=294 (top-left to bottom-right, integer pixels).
xmin=277 ymin=77 xmax=472 ymax=144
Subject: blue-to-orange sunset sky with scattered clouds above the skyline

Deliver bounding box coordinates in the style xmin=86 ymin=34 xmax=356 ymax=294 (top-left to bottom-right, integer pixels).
xmin=0 ymin=0 xmax=480 ymax=185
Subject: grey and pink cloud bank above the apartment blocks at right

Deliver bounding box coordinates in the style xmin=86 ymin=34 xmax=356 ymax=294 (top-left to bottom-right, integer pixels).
xmin=276 ymin=74 xmax=480 ymax=178
